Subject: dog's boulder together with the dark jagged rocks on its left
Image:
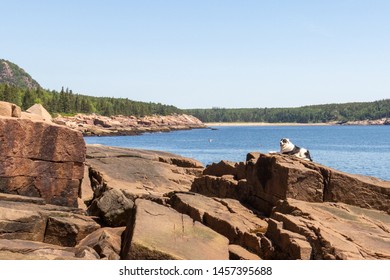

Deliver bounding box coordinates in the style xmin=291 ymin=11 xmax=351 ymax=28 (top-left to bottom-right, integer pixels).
xmin=191 ymin=153 xmax=390 ymax=214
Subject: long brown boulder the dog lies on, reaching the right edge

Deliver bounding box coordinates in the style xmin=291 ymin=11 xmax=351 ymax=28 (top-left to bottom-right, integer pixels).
xmin=247 ymin=154 xmax=390 ymax=213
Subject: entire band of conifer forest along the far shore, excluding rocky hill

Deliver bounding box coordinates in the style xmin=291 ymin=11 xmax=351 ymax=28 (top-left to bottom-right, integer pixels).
xmin=0 ymin=84 xmax=390 ymax=123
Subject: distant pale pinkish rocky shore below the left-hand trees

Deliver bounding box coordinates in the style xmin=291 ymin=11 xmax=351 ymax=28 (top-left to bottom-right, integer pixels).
xmin=53 ymin=114 xmax=206 ymax=136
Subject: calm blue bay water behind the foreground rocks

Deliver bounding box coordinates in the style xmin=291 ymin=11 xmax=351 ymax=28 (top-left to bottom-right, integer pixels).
xmin=85 ymin=126 xmax=390 ymax=180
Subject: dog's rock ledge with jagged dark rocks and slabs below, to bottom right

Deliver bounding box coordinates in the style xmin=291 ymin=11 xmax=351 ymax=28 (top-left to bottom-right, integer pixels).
xmin=191 ymin=153 xmax=390 ymax=259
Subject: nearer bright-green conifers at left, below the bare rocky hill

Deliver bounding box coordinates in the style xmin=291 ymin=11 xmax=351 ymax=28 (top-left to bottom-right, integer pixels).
xmin=0 ymin=84 xmax=181 ymax=116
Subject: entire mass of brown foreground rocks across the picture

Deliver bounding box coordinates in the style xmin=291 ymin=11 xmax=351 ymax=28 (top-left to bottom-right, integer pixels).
xmin=0 ymin=103 xmax=390 ymax=260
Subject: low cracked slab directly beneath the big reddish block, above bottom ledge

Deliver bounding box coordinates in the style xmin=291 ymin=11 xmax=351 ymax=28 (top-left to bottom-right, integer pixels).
xmin=0 ymin=198 xmax=100 ymax=247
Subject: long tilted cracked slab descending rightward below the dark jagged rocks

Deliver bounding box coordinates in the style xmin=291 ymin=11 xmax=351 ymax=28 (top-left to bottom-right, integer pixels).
xmin=170 ymin=193 xmax=268 ymax=253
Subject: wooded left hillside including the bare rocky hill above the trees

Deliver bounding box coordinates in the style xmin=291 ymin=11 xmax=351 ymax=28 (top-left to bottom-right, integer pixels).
xmin=0 ymin=59 xmax=181 ymax=116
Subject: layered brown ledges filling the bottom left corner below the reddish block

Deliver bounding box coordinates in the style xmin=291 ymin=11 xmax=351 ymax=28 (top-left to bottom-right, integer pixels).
xmin=0 ymin=194 xmax=100 ymax=259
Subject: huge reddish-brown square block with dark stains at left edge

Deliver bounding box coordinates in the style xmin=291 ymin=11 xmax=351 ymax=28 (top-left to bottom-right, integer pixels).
xmin=0 ymin=117 xmax=86 ymax=207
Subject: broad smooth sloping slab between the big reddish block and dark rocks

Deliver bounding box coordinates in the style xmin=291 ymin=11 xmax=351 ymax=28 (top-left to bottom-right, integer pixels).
xmin=87 ymin=145 xmax=203 ymax=196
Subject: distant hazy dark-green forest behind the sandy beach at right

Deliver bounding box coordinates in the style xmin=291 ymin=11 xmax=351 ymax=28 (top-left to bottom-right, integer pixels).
xmin=184 ymin=99 xmax=390 ymax=123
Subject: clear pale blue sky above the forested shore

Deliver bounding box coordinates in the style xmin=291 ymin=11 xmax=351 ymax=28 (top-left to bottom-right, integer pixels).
xmin=0 ymin=0 xmax=390 ymax=109
